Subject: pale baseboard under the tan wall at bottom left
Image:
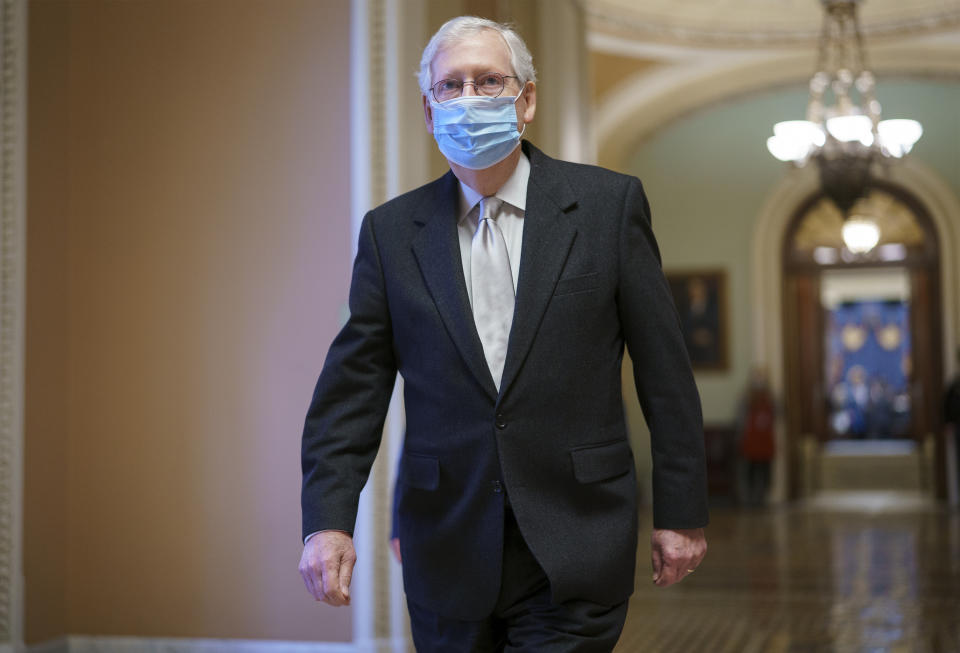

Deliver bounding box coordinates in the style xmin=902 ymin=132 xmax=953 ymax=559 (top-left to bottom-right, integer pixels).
xmin=27 ymin=635 xmax=362 ymax=653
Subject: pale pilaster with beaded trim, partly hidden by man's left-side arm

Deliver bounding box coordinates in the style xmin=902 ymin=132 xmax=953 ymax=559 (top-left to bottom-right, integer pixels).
xmin=350 ymin=0 xmax=429 ymax=652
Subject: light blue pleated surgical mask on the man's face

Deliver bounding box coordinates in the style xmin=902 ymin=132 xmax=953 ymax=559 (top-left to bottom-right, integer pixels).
xmin=430 ymin=95 xmax=527 ymax=170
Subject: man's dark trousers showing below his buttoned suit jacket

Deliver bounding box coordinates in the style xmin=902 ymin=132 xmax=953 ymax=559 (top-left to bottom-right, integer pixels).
xmin=407 ymin=508 xmax=627 ymax=653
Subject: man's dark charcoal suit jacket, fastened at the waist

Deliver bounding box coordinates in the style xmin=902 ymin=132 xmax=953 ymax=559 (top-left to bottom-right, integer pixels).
xmin=302 ymin=142 xmax=707 ymax=619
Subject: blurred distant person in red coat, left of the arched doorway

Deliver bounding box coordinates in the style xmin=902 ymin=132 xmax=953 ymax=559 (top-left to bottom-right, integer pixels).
xmin=740 ymin=368 xmax=776 ymax=506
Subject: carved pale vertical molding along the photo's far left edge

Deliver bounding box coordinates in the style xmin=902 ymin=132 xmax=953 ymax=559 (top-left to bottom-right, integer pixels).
xmin=0 ymin=0 xmax=27 ymax=651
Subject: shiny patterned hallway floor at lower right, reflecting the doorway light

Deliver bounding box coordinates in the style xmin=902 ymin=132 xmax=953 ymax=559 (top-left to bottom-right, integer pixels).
xmin=616 ymin=493 xmax=960 ymax=653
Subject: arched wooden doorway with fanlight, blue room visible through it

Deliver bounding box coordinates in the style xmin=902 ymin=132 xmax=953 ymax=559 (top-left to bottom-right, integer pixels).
xmin=782 ymin=182 xmax=944 ymax=497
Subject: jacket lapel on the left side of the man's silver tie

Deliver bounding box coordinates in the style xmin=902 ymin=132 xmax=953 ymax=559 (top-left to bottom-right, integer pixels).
xmin=413 ymin=172 xmax=497 ymax=399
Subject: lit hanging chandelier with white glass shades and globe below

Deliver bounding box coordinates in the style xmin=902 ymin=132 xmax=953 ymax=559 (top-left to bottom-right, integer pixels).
xmin=767 ymin=0 xmax=923 ymax=252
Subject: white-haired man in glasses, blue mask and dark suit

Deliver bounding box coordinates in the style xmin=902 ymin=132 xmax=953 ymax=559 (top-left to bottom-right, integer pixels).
xmin=300 ymin=17 xmax=707 ymax=652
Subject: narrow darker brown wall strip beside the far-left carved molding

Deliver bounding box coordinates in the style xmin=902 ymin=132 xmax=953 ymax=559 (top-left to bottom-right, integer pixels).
xmin=23 ymin=2 xmax=70 ymax=641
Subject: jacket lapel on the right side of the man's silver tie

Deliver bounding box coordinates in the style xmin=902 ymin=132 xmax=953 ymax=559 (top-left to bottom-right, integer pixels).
xmin=498 ymin=141 xmax=577 ymax=397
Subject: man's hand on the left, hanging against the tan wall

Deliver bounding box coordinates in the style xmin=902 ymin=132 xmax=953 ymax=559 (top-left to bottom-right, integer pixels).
xmin=300 ymin=531 xmax=357 ymax=605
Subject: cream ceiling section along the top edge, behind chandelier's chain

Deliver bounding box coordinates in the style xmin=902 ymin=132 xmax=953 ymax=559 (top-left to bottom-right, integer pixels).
xmin=583 ymin=0 xmax=960 ymax=48
